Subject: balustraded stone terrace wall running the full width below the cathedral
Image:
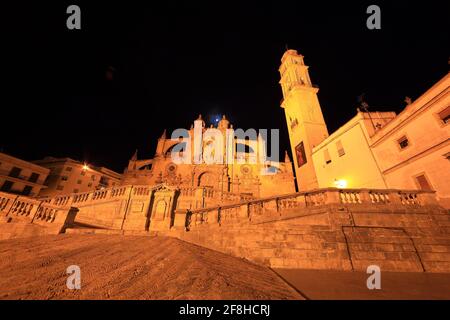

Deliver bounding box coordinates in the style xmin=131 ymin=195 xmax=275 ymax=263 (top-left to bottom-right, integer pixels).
xmin=6 ymin=186 xmax=450 ymax=273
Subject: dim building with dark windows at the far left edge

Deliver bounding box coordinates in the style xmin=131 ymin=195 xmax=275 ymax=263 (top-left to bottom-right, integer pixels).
xmin=0 ymin=153 xmax=50 ymax=197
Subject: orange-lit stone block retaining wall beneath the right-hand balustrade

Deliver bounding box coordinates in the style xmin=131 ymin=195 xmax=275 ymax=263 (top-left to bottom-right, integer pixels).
xmin=172 ymin=195 xmax=450 ymax=272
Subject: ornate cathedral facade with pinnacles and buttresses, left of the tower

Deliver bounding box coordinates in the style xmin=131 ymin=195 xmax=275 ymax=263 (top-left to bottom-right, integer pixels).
xmin=122 ymin=115 xmax=295 ymax=209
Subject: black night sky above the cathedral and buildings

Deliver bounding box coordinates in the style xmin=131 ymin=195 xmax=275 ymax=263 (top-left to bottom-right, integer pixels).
xmin=0 ymin=0 xmax=450 ymax=171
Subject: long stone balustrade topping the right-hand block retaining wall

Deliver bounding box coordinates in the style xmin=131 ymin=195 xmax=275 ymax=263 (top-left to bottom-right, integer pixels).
xmin=179 ymin=188 xmax=438 ymax=230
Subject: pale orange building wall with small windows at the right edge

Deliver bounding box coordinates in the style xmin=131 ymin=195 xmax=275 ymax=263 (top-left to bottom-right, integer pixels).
xmin=371 ymin=74 xmax=450 ymax=207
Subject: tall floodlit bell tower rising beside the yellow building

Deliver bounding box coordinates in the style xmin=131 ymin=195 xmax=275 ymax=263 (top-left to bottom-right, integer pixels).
xmin=279 ymin=50 xmax=328 ymax=191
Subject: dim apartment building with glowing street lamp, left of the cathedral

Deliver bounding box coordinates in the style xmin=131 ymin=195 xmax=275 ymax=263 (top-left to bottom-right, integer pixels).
xmin=34 ymin=157 xmax=122 ymax=197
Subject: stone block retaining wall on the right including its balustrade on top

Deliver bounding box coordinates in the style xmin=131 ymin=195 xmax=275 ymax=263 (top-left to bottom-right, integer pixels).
xmin=172 ymin=189 xmax=450 ymax=272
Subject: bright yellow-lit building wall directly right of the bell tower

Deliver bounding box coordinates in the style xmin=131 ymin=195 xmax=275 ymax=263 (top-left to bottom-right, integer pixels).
xmin=312 ymin=112 xmax=395 ymax=189
